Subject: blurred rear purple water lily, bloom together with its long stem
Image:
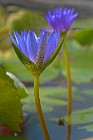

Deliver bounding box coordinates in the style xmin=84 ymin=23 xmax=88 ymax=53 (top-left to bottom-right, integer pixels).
xmin=45 ymin=8 xmax=78 ymax=115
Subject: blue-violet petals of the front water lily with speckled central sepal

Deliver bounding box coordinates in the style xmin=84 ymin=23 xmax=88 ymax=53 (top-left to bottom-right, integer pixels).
xmin=10 ymin=30 xmax=60 ymax=74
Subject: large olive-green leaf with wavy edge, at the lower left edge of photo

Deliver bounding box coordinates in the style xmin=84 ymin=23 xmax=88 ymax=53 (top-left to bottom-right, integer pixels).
xmin=0 ymin=68 xmax=22 ymax=131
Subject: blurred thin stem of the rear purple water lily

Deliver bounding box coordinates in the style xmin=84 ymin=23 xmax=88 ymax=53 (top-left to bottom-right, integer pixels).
xmin=63 ymin=41 xmax=72 ymax=115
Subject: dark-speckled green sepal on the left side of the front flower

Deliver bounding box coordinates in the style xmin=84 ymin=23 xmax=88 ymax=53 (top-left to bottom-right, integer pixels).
xmin=12 ymin=43 xmax=38 ymax=75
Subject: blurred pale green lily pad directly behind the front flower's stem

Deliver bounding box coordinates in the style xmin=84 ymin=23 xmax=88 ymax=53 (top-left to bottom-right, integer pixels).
xmin=23 ymin=87 xmax=72 ymax=112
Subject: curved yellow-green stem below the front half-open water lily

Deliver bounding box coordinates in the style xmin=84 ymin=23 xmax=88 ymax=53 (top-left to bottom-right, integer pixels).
xmin=34 ymin=75 xmax=50 ymax=140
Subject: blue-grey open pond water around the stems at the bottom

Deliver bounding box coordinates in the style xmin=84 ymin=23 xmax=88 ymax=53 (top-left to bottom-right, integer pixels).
xmin=21 ymin=83 xmax=93 ymax=140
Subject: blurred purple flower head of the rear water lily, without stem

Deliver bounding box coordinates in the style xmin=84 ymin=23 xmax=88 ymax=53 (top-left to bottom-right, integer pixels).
xmin=45 ymin=8 xmax=78 ymax=31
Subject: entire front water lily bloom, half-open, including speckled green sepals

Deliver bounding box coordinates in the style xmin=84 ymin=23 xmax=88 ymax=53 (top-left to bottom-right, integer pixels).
xmin=10 ymin=30 xmax=62 ymax=75
